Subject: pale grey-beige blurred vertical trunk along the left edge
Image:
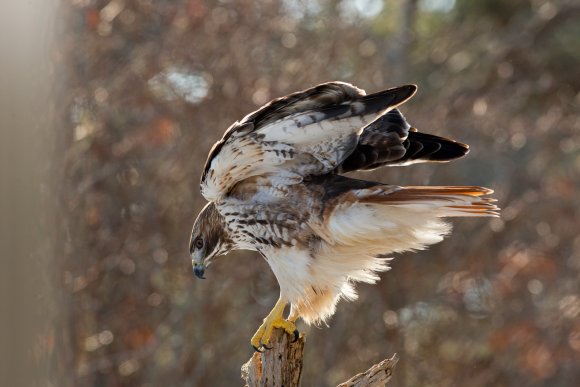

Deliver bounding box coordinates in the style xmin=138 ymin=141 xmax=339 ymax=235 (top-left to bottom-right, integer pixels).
xmin=0 ymin=0 xmax=55 ymax=386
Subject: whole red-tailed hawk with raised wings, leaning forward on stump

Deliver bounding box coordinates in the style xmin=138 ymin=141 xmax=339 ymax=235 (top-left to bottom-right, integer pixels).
xmin=190 ymin=82 xmax=498 ymax=350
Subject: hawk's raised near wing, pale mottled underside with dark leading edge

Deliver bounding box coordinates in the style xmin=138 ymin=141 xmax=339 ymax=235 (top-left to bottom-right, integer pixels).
xmin=201 ymin=82 xmax=416 ymax=201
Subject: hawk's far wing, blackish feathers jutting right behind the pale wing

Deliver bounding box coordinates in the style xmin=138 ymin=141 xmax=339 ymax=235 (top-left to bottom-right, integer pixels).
xmin=337 ymin=109 xmax=469 ymax=173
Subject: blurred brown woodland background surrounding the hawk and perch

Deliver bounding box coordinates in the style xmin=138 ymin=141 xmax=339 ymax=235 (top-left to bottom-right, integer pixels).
xmin=2 ymin=0 xmax=580 ymax=386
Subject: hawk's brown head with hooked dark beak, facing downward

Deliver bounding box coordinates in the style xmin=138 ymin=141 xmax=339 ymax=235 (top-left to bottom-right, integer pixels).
xmin=189 ymin=203 xmax=232 ymax=278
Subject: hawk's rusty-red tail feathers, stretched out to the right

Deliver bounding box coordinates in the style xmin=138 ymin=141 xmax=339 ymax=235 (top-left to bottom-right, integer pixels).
xmin=360 ymin=186 xmax=499 ymax=217
